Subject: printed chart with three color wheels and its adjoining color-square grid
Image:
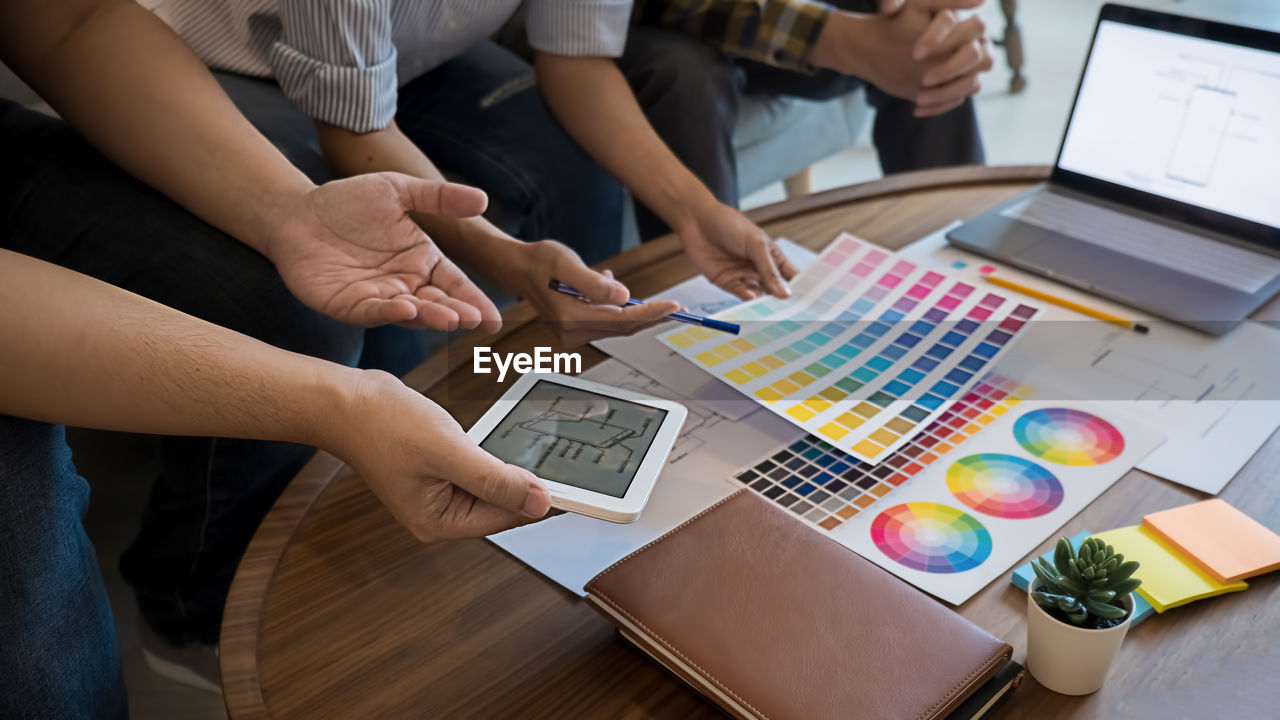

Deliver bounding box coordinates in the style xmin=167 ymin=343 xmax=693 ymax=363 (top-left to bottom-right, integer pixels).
xmin=733 ymin=394 xmax=1162 ymax=605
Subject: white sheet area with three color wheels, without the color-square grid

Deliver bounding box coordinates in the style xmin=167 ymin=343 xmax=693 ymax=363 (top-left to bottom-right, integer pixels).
xmin=831 ymin=400 xmax=1164 ymax=605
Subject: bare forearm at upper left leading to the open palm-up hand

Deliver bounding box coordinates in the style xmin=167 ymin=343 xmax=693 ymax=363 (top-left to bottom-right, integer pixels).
xmin=0 ymin=0 xmax=314 ymax=255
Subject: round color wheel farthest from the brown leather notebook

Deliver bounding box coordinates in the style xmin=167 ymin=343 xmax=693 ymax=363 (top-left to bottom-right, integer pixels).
xmin=1014 ymin=407 xmax=1124 ymax=465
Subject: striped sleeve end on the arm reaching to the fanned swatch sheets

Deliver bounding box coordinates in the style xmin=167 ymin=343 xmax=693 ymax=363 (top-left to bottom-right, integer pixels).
xmin=526 ymin=0 xmax=631 ymax=58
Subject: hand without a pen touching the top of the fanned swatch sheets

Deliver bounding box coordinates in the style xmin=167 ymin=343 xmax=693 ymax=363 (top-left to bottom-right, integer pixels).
xmin=675 ymin=201 xmax=796 ymax=300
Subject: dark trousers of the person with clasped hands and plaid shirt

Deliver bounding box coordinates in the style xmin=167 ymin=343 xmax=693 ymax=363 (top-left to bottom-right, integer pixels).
xmin=618 ymin=26 xmax=984 ymax=240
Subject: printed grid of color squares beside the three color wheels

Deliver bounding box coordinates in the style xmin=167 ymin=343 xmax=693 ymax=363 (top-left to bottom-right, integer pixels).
xmin=733 ymin=375 xmax=1032 ymax=530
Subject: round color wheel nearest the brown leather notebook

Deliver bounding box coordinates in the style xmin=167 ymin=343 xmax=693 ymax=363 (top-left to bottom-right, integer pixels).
xmin=872 ymin=502 xmax=991 ymax=573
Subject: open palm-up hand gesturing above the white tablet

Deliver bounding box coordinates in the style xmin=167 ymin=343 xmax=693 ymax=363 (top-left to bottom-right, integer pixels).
xmin=265 ymin=173 xmax=502 ymax=331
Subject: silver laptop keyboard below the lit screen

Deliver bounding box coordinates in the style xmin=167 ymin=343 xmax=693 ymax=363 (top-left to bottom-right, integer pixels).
xmin=1001 ymin=192 xmax=1280 ymax=295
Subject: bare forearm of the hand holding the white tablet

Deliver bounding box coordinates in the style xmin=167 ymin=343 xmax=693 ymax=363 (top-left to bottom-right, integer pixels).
xmin=0 ymin=250 xmax=360 ymax=445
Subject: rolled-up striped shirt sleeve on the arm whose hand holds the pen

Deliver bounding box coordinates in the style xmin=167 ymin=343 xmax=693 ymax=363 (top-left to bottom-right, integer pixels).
xmin=268 ymin=0 xmax=397 ymax=132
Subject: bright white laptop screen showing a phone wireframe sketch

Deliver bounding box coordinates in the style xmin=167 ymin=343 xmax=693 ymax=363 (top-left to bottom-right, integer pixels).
xmin=1055 ymin=13 xmax=1280 ymax=234
